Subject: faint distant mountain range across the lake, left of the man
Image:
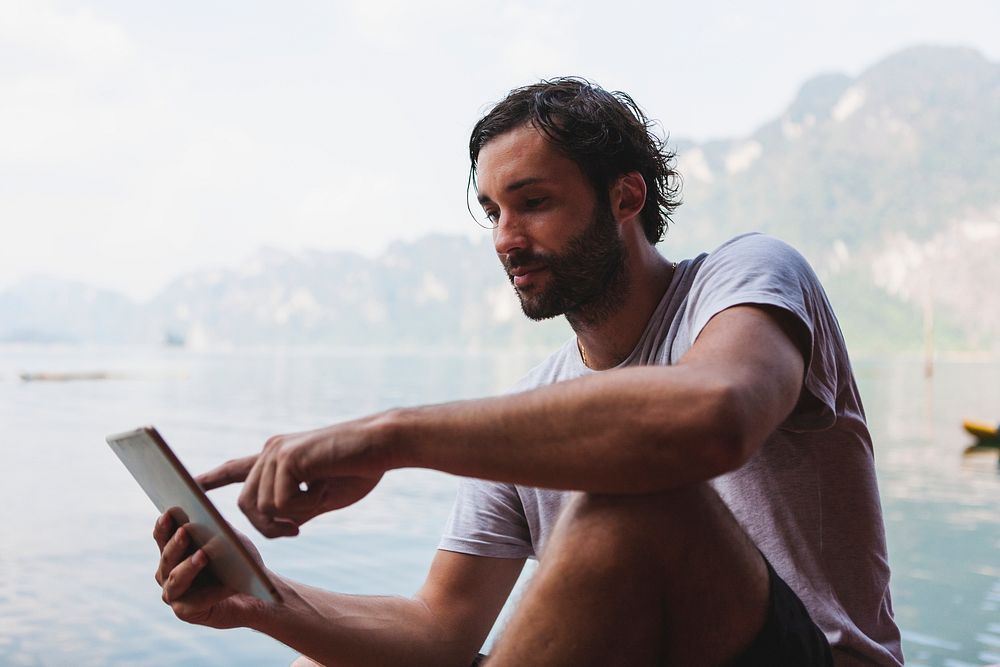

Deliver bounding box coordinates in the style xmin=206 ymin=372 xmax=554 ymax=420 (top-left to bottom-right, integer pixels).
xmin=0 ymin=235 xmax=570 ymax=349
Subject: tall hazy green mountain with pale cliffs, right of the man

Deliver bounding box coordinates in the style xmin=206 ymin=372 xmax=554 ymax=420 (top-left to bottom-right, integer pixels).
xmin=667 ymin=47 xmax=1000 ymax=350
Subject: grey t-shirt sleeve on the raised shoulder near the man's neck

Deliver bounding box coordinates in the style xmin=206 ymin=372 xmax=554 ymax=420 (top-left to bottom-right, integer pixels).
xmin=687 ymin=234 xmax=846 ymax=431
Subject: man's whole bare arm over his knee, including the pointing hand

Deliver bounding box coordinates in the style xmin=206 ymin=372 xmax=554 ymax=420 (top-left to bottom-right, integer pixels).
xmin=207 ymin=306 xmax=805 ymax=537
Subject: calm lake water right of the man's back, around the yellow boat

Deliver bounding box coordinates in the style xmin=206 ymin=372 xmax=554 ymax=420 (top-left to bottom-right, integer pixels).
xmin=859 ymin=363 xmax=1000 ymax=665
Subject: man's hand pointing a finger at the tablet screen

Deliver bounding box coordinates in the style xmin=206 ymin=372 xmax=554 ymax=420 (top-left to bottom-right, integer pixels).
xmin=196 ymin=420 xmax=387 ymax=537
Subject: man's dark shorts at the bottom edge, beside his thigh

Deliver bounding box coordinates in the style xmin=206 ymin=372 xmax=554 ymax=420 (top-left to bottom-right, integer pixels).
xmin=472 ymin=558 xmax=833 ymax=667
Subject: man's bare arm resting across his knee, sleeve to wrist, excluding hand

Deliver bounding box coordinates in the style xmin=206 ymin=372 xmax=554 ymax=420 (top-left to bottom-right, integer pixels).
xmin=384 ymin=306 xmax=804 ymax=493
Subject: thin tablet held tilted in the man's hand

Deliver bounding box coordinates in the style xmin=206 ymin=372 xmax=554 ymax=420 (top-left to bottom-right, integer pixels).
xmin=106 ymin=426 xmax=281 ymax=602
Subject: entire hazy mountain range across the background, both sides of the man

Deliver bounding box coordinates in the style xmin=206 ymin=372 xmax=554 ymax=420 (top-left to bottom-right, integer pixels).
xmin=0 ymin=47 xmax=1000 ymax=352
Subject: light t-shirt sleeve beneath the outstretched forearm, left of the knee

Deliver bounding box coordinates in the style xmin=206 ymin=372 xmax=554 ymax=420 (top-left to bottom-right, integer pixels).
xmin=438 ymin=478 xmax=534 ymax=558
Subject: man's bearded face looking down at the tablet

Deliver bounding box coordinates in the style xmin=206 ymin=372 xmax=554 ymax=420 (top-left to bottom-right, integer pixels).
xmin=478 ymin=126 xmax=627 ymax=324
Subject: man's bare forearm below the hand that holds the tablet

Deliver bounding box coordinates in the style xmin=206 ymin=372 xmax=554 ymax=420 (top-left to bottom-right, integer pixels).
xmin=246 ymin=578 xmax=474 ymax=667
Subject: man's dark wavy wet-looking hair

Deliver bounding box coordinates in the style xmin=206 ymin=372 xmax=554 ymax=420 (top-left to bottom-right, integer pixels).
xmin=469 ymin=77 xmax=681 ymax=244
